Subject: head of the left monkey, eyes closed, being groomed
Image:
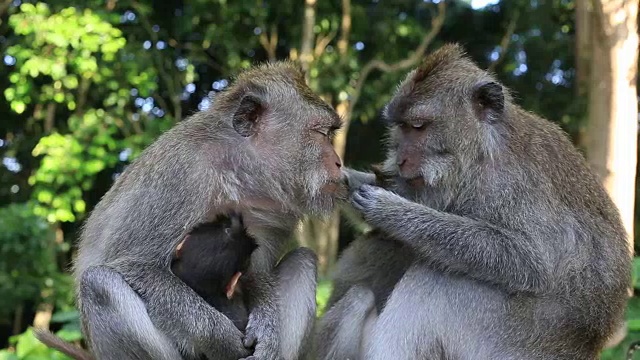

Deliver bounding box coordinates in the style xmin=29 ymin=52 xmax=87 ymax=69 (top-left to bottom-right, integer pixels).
xmin=233 ymin=69 xmax=343 ymax=214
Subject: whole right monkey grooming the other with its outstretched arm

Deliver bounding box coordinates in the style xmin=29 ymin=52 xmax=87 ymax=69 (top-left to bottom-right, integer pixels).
xmin=318 ymin=44 xmax=631 ymax=360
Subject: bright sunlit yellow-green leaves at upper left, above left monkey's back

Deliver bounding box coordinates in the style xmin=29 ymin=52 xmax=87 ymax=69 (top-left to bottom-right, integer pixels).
xmin=4 ymin=3 xmax=179 ymax=223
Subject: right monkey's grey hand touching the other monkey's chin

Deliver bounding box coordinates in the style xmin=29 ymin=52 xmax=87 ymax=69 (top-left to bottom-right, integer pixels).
xmin=351 ymin=184 xmax=411 ymax=222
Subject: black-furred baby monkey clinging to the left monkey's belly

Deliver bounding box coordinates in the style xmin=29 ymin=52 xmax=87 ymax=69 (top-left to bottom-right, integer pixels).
xmin=171 ymin=213 xmax=258 ymax=331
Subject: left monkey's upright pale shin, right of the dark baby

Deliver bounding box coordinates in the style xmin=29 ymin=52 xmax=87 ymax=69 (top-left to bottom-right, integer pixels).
xmin=275 ymin=247 xmax=318 ymax=360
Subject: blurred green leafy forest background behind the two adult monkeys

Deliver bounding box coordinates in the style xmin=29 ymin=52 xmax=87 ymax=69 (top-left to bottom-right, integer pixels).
xmin=0 ymin=0 xmax=640 ymax=360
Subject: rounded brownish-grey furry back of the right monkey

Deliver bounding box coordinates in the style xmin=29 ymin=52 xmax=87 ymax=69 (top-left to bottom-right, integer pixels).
xmin=471 ymin=106 xmax=631 ymax=359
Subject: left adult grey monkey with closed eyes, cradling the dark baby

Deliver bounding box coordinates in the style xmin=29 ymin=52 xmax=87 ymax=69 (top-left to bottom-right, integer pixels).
xmin=73 ymin=62 xmax=343 ymax=360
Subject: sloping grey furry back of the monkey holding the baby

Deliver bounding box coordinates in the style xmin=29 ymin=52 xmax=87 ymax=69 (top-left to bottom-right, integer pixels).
xmin=74 ymin=114 xmax=221 ymax=280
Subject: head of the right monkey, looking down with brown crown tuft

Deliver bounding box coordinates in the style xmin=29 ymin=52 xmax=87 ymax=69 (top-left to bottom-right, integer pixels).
xmin=384 ymin=50 xmax=504 ymax=197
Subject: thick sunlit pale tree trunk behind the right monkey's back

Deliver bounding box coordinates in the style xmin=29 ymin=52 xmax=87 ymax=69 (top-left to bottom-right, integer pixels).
xmin=586 ymin=0 xmax=638 ymax=254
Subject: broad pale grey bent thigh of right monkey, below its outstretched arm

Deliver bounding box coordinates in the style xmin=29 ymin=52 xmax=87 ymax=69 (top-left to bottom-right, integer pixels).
xmin=364 ymin=262 xmax=516 ymax=360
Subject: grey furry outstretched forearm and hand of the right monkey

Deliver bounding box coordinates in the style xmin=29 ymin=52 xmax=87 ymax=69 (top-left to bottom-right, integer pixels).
xmin=352 ymin=185 xmax=550 ymax=293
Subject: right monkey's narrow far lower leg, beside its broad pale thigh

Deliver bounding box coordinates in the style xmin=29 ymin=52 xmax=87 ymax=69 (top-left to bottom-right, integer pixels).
xmin=315 ymin=285 xmax=377 ymax=360
